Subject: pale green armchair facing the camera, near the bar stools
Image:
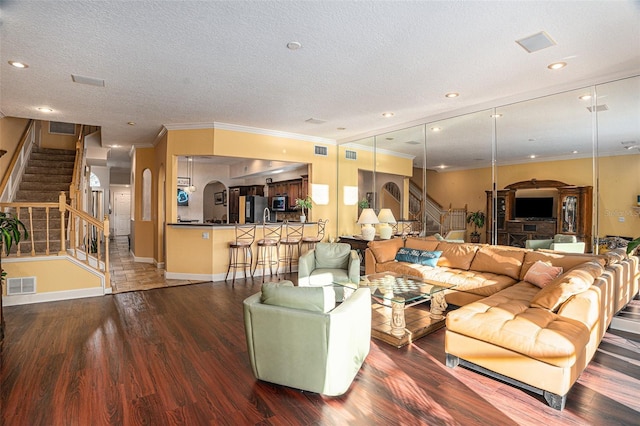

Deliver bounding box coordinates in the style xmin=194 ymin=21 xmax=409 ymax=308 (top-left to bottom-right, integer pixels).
xmin=298 ymin=243 xmax=360 ymax=290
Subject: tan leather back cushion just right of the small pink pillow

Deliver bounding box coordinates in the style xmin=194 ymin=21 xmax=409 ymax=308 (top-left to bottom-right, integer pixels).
xmin=531 ymin=261 xmax=604 ymax=312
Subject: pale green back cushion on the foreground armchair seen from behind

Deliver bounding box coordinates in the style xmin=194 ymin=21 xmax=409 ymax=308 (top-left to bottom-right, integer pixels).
xmin=260 ymin=281 xmax=336 ymax=313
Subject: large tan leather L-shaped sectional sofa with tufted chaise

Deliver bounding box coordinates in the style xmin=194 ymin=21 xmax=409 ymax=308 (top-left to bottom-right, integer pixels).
xmin=365 ymin=238 xmax=639 ymax=410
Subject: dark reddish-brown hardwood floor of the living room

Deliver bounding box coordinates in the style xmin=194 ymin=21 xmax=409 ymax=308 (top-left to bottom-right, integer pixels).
xmin=0 ymin=279 xmax=640 ymax=426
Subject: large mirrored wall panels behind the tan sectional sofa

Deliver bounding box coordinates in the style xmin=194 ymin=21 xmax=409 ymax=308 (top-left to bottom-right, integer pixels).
xmin=338 ymin=76 xmax=640 ymax=251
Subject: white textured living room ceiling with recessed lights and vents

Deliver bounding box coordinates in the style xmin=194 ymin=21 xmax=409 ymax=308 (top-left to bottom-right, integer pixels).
xmin=0 ymin=0 xmax=640 ymax=168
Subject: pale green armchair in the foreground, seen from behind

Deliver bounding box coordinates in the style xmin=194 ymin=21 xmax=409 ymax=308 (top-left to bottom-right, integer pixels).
xmin=243 ymin=281 xmax=371 ymax=396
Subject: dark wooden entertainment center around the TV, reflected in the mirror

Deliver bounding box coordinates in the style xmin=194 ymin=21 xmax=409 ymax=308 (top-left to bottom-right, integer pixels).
xmin=486 ymin=179 xmax=593 ymax=252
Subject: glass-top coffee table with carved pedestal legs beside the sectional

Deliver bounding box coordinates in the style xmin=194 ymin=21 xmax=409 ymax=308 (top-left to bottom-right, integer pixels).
xmin=335 ymin=272 xmax=455 ymax=347
